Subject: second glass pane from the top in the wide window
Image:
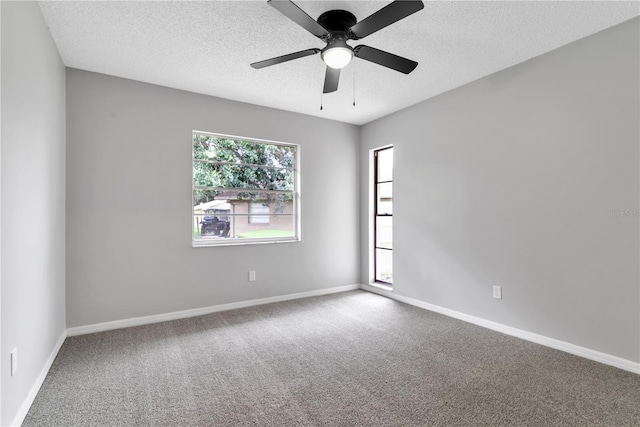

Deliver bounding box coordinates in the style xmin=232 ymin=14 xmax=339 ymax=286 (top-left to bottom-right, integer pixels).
xmin=193 ymin=161 xmax=294 ymax=191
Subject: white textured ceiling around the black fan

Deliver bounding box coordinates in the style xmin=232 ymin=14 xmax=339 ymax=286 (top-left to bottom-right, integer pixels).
xmin=40 ymin=0 xmax=640 ymax=124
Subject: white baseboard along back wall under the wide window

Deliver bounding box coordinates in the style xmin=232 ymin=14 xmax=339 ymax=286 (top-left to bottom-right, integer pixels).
xmin=67 ymin=284 xmax=360 ymax=337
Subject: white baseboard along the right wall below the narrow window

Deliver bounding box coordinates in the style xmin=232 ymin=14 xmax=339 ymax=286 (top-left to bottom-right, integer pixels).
xmin=360 ymin=285 xmax=640 ymax=374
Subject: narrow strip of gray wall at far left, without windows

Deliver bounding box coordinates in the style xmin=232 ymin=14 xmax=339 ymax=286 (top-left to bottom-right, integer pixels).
xmin=0 ymin=1 xmax=66 ymax=425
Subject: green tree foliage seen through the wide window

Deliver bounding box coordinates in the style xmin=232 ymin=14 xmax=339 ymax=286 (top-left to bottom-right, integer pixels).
xmin=193 ymin=134 xmax=295 ymax=213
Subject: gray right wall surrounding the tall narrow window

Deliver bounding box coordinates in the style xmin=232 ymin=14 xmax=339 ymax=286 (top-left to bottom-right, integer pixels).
xmin=360 ymin=19 xmax=640 ymax=362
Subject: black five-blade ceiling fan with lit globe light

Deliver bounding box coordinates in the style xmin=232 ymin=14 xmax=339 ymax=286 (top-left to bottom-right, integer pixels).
xmin=251 ymin=0 xmax=424 ymax=93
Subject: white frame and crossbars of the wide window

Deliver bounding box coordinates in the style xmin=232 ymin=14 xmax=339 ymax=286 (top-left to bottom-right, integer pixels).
xmin=190 ymin=130 xmax=302 ymax=248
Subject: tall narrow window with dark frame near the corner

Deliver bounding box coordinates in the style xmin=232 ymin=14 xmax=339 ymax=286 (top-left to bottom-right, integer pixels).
xmin=373 ymin=147 xmax=393 ymax=285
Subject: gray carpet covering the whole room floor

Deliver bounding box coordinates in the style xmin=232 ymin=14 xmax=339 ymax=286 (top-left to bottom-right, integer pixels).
xmin=23 ymin=291 xmax=640 ymax=426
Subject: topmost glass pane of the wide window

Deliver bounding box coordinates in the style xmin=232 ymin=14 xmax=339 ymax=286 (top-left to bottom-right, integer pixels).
xmin=193 ymin=134 xmax=295 ymax=168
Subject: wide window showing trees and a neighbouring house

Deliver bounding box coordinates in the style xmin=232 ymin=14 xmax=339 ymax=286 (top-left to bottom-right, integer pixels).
xmin=192 ymin=132 xmax=299 ymax=246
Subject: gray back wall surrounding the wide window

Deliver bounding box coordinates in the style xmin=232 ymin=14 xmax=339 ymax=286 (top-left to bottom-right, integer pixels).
xmin=67 ymin=69 xmax=359 ymax=327
